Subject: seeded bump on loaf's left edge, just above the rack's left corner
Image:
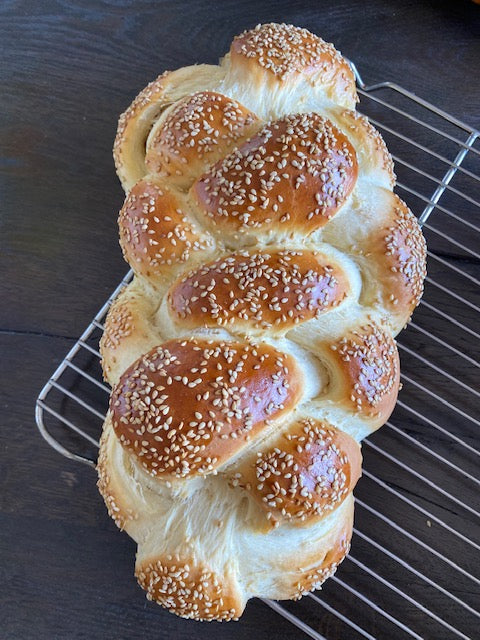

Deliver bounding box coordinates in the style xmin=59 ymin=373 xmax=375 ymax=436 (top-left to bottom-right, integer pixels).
xmin=118 ymin=179 xmax=213 ymax=286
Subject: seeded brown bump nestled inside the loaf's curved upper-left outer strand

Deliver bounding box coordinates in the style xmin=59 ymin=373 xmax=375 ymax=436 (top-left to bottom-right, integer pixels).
xmin=146 ymin=91 xmax=258 ymax=187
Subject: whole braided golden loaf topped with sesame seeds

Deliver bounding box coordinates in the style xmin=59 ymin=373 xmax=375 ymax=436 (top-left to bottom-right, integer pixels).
xmin=98 ymin=24 xmax=426 ymax=620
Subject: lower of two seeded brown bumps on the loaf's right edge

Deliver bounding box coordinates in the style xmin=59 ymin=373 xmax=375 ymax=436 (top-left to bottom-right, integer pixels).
xmin=330 ymin=324 xmax=400 ymax=428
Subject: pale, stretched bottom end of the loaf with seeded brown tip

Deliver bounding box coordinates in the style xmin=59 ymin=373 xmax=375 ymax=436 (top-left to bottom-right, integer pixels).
xmin=98 ymin=417 xmax=358 ymax=620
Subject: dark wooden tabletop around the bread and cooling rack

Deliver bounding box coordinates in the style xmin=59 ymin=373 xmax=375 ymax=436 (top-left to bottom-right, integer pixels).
xmin=0 ymin=0 xmax=480 ymax=640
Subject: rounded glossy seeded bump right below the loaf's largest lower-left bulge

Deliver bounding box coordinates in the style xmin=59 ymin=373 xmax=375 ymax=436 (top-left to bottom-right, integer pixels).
xmin=232 ymin=418 xmax=362 ymax=525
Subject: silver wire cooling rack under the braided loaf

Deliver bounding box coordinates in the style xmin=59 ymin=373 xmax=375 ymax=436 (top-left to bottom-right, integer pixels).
xmin=36 ymin=65 xmax=480 ymax=640
